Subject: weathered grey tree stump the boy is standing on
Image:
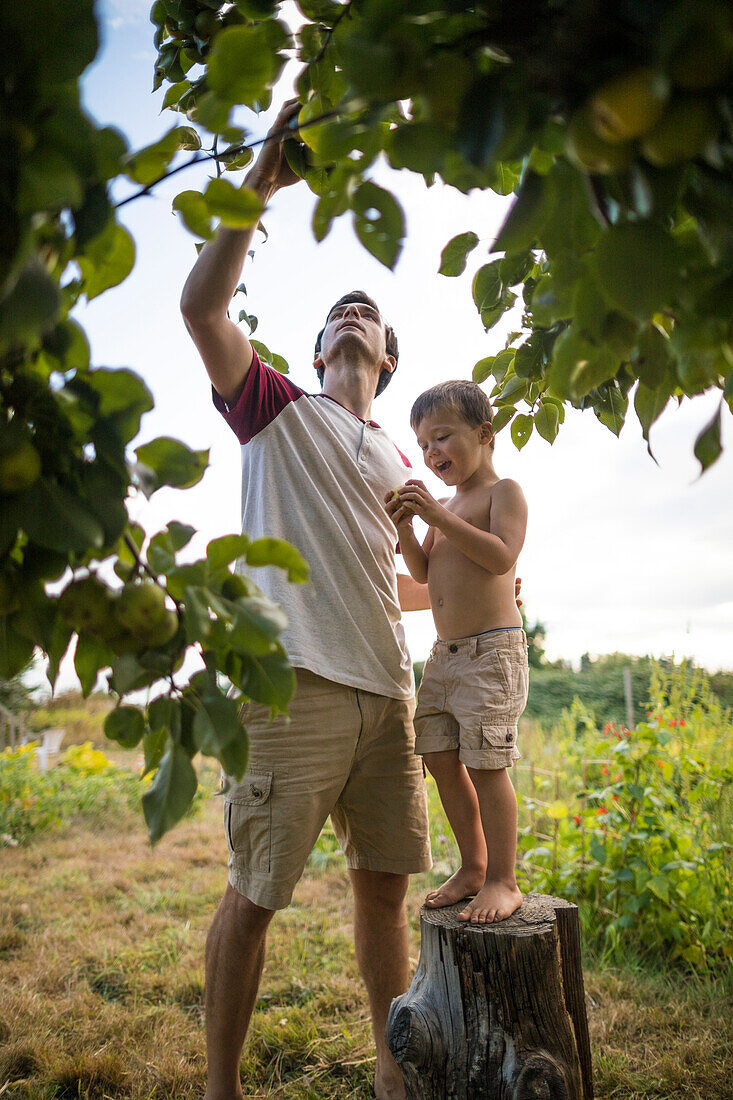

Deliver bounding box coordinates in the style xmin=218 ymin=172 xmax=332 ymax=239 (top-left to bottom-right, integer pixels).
xmin=386 ymin=894 xmax=593 ymax=1100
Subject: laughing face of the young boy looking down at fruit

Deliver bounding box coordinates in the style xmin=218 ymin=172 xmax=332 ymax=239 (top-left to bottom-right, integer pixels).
xmin=415 ymin=408 xmax=492 ymax=485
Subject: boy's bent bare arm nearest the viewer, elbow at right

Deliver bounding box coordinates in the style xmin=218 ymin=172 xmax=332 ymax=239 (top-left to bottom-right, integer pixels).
xmin=400 ymin=479 xmax=527 ymax=576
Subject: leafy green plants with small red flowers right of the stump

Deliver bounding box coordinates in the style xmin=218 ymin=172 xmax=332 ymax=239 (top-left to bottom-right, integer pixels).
xmin=519 ymin=663 xmax=733 ymax=969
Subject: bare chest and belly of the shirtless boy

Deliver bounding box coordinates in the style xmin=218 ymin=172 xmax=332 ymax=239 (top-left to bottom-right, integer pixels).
xmin=424 ymin=479 xmax=522 ymax=641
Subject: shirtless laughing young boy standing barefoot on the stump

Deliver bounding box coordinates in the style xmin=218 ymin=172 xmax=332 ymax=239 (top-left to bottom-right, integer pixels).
xmin=385 ymin=381 xmax=528 ymax=923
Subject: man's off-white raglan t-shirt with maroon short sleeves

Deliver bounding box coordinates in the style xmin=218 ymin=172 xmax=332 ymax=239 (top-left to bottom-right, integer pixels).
xmin=214 ymin=353 xmax=414 ymax=699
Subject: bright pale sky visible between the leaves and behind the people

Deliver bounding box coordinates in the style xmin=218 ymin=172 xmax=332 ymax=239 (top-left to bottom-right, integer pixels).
xmin=64 ymin=0 xmax=733 ymax=669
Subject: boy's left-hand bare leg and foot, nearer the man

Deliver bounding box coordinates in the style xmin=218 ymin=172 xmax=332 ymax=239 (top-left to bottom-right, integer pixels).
xmin=423 ymin=749 xmax=486 ymax=909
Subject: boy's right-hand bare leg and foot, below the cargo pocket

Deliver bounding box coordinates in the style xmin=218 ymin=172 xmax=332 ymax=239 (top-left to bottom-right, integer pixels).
xmin=458 ymin=768 xmax=522 ymax=924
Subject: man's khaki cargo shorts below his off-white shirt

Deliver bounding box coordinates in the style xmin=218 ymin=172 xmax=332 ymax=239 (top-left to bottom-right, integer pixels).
xmin=223 ymin=669 xmax=431 ymax=909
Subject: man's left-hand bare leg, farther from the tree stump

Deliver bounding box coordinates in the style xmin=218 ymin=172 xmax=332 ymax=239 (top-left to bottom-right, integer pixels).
xmin=205 ymin=886 xmax=274 ymax=1100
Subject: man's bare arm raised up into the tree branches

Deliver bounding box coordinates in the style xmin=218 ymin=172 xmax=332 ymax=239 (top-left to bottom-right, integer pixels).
xmin=180 ymin=100 xmax=299 ymax=406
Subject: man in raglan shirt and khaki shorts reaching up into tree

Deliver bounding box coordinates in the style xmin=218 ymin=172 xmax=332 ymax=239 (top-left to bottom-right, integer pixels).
xmin=182 ymin=103 xmax=430 ymax=1100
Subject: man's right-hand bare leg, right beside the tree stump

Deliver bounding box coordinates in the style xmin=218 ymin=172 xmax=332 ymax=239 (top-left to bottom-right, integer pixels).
xmin=349 ymin=870 xmax=409 ymax=1100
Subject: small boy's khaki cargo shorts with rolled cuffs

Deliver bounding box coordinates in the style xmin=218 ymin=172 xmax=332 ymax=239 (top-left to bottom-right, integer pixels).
xmin=415 ymin=629 xmax=529 ymax=770
